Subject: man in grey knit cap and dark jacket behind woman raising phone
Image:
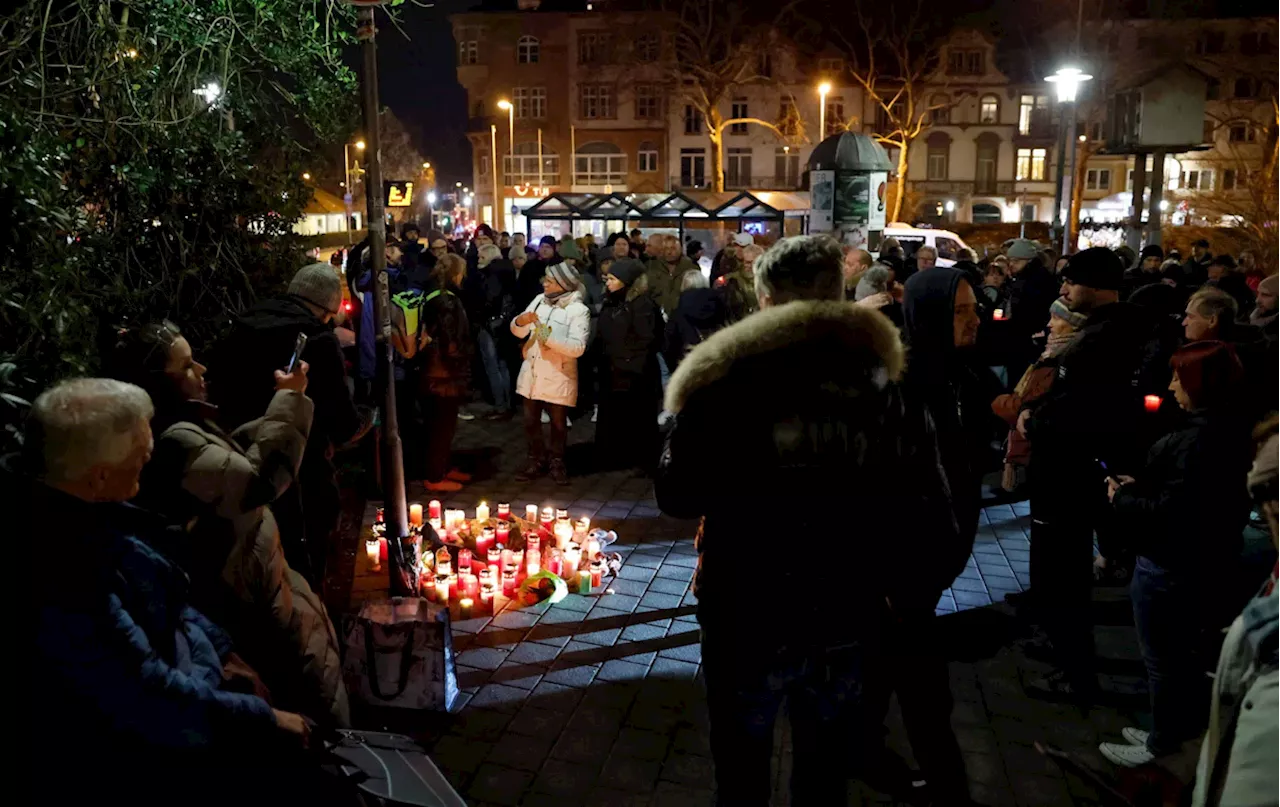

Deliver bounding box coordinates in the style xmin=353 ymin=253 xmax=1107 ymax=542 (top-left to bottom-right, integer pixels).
xmin=210 ymin=264 xmax=369 ymax=581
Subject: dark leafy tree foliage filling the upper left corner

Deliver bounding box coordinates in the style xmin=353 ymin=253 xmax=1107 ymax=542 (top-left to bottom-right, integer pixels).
xmin=0 ymin=0 xmax=356 ymax=402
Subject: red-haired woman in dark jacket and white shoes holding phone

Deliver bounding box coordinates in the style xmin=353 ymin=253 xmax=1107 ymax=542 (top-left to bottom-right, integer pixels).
xmin=1098 ymin=342 xmax=1253 ymax=767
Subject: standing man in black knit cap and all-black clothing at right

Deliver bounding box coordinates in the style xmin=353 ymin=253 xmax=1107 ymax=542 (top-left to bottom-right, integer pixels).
xmin=1018 ymin=247 xmax=1155 ymax=698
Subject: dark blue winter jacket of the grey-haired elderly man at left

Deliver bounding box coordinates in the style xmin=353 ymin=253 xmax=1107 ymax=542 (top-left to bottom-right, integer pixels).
xmin=24 ymin=469 xmax=280 ymax=804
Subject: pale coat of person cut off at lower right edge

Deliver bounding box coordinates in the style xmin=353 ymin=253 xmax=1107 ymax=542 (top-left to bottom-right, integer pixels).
xmin=1192 ymin=581 xmax=1280 ymax=807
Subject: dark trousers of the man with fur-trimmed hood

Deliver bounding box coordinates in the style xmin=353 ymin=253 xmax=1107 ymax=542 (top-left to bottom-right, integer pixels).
xmin=699 ymin=615 xmax=864 ymax=807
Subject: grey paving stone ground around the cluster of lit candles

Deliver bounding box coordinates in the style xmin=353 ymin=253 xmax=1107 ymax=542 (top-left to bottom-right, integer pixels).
xmin=340 ymin=419 xmax=1143 ymax=807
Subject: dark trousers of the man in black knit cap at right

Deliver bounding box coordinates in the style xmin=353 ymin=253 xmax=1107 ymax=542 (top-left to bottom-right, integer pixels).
xmin=1030 ymin=452 xmax=1106 ymax=678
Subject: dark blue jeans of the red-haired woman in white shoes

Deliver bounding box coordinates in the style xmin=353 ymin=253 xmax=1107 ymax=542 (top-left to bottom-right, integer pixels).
xmin=1129 ymin=555 xmax=1210 ymax=756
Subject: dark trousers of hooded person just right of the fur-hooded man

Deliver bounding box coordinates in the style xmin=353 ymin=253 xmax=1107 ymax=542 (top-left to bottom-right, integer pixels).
xmin=867 ymin=610 xmax=969 ymax=799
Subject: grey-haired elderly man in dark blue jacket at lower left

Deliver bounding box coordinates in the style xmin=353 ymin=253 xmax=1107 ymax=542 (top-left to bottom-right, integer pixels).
xmin=23 ymin=378 xmax=308 ymax=804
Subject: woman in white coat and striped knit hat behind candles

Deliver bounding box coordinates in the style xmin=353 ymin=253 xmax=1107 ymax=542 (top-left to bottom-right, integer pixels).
xmin=511 ymin=263 xmax=591 ymax=484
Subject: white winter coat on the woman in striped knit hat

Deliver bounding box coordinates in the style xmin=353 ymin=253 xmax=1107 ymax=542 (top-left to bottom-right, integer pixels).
xmin=511 ymin=291 xmax=591 ymax=406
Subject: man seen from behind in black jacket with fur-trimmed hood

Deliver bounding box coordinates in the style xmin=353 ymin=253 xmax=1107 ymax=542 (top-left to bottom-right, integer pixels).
xmin=657 ymin=236 xmax=964 ymax=807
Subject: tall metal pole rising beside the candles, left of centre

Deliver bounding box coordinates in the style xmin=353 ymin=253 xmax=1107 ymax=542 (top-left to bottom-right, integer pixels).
xmin=356 ymin=6 xmax=417 ymax=596
